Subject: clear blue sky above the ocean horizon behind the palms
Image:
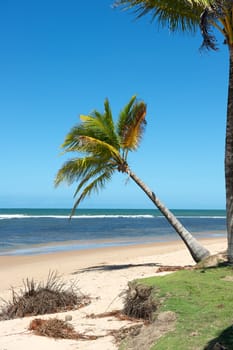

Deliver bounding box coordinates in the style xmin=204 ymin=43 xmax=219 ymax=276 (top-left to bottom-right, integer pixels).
xmin=0 ymin=0 xmax=228 ymax=209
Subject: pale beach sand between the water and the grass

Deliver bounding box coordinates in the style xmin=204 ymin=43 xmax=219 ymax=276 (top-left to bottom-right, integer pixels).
xmin=0 ymin=238 xmax=226 ymax=350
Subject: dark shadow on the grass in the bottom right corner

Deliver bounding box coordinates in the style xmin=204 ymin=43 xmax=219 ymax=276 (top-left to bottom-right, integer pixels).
xmin=204 ymin=325 xmax=233 ymax=350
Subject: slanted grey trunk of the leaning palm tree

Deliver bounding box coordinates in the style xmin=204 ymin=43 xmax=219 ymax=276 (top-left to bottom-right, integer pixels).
xmin=127 ymin=168 xmax=210 ymax=262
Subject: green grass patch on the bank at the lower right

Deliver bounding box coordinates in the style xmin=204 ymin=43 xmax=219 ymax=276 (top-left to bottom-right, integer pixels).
xmin=135 ymin=267 xmax=233 ymax=350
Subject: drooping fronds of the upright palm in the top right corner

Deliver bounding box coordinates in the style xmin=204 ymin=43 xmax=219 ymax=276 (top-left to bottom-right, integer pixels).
xmin=115 ymin=0 xmax=233 ymax=50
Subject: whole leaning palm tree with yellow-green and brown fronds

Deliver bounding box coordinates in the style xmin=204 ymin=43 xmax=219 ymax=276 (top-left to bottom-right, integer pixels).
xmin=55 ymin=96 xmax=209 ymax=262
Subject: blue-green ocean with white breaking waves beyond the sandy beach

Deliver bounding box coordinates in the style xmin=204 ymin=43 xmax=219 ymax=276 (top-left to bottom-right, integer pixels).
xmin=0 ymin=209 xmax=226 ymax=255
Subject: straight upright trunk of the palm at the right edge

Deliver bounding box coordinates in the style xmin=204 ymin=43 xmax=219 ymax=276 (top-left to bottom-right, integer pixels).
xmin=225 ymin=45 xmax=233 ymax=264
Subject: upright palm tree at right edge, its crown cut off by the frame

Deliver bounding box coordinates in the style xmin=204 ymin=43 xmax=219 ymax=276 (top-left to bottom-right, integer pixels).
xmin=115 ymin=0 xmax=233 ymax=264
